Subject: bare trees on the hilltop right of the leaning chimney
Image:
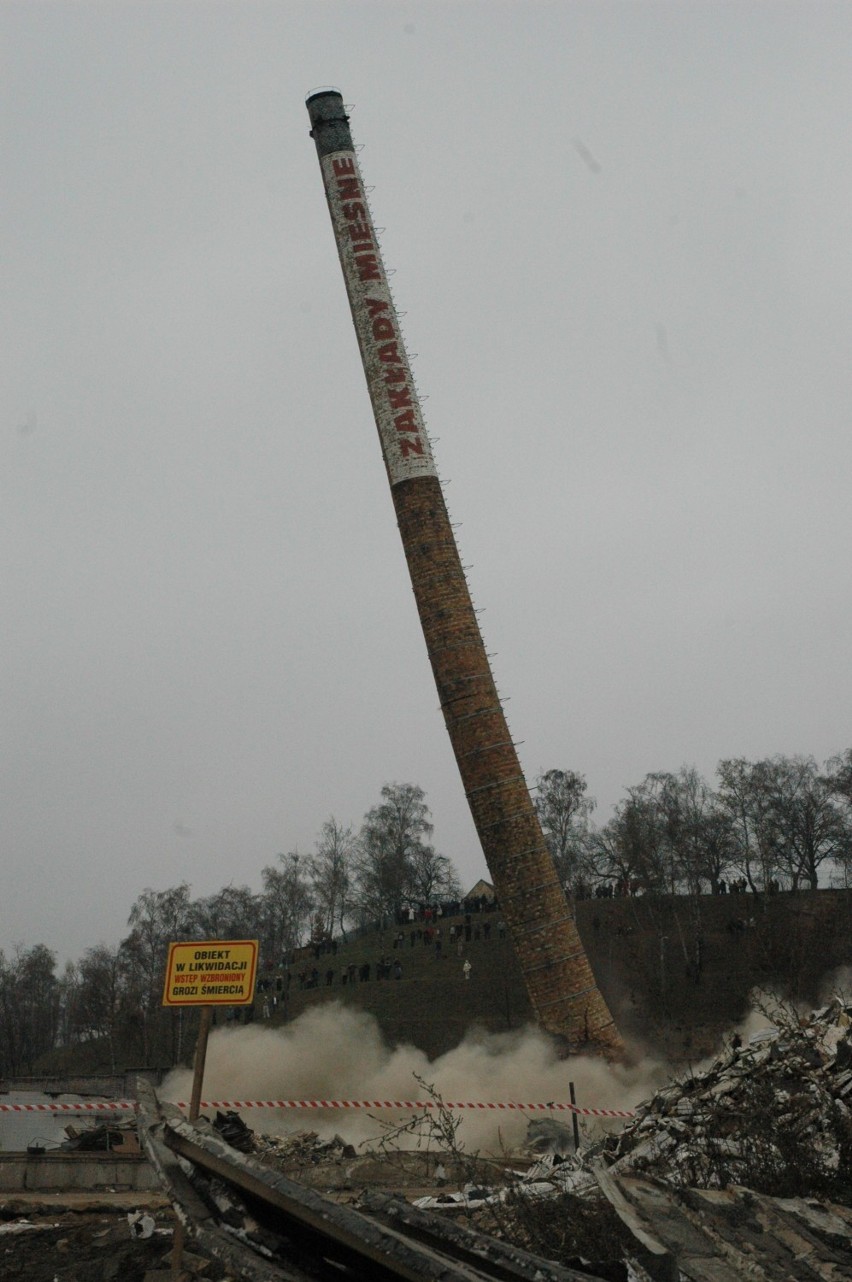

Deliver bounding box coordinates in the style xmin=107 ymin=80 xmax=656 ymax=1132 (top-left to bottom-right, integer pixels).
xmin=536 ymin=749 xmax=852 ymax=897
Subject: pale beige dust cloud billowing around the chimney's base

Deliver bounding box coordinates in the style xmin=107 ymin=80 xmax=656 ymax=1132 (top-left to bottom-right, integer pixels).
xmin=161 ymin=1003 xmax=670 ymax=1154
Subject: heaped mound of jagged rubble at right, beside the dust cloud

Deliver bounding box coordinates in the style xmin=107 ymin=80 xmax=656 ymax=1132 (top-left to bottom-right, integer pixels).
xmin=600 ymin=999 xmax=852 ymax=1201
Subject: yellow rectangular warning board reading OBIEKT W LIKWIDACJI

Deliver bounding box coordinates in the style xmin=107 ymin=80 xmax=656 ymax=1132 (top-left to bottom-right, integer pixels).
xmin=163 ymin=940 xmax=258 ymax=1006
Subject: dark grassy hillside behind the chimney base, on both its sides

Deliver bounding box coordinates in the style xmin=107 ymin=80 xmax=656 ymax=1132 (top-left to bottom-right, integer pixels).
xmin=270 ymin=891 xmax=852 ymax=1061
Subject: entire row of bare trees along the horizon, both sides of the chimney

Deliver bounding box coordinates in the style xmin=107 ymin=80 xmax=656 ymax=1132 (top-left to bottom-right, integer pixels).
xmin=0 ymin=749 xmax=852 ymax=1076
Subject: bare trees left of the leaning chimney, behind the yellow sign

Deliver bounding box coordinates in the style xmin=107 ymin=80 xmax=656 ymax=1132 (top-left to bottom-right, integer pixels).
xmin=0 ymin=783 xmax=461 ymax=1077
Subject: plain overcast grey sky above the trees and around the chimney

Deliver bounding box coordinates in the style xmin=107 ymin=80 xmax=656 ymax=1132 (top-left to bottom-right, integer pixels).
xmin=0 ymin=0 xmax=852 ymax=958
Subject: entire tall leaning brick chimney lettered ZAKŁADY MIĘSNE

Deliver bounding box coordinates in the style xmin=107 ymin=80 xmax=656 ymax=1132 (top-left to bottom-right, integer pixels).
xmin=306 ymin=88 xmax=621 ymax=1055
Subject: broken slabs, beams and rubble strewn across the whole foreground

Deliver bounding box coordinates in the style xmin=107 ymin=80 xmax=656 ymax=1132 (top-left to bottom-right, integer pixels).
xmin=11 ymin=999 xmax=852 ymax=1282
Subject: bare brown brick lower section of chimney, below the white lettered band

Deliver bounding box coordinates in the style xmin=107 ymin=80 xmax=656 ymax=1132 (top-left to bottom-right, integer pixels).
xmin=392 ymin=477 xmax=619 ymax=1049
